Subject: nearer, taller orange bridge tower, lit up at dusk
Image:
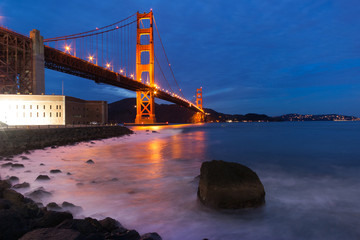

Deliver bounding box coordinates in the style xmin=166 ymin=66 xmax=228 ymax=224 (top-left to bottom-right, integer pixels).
xmin=135 ymin=11 xmax=156 ymax=124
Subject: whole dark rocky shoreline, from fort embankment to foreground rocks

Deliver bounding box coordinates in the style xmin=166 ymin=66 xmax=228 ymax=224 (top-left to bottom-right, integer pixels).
xmin=0 ymin=126 xmax=162 ymax=240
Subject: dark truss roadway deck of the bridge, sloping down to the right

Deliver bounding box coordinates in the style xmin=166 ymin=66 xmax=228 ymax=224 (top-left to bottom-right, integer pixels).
xmin=44 ymin=46 xmax=204 ymax=113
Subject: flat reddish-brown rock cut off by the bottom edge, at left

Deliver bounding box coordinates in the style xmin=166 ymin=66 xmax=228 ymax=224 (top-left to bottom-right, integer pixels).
xmin=20 ymin=228 xmax=81 ymax=240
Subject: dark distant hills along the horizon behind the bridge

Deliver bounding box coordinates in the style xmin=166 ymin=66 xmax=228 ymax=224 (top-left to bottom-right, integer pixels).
xmin=109 ymin=98 xmax=360 ymax=123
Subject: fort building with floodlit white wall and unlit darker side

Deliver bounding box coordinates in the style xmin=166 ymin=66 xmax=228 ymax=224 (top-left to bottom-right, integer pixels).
xmin=0 ymin=94 xmax=107 ymax=126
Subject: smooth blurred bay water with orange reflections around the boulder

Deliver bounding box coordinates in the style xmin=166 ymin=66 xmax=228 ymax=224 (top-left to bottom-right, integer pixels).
xmin=0 ymin=122 xmax=360 ymax=240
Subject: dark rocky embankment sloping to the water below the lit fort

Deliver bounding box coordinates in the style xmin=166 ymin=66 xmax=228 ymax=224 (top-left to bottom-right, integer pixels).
xmin=0 ymin=126 xmax=133 ymax=157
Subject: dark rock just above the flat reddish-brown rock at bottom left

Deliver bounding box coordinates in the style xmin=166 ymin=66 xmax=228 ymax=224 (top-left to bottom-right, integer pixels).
xmin=34 ymin=211 xmax=73 ymax=228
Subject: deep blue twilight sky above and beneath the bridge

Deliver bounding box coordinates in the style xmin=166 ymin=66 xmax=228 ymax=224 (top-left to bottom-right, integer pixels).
xmin=0 ymin=0 xmax=360 ymax=116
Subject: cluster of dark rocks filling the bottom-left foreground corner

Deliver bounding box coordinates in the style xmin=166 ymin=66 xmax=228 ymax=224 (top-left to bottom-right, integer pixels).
xmin=0 ymin=180 xmax=161 ymax=240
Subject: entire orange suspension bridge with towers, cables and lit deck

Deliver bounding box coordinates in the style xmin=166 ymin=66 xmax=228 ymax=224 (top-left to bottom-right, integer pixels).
xmin=0 ymin=11 xmax=204 ymax=124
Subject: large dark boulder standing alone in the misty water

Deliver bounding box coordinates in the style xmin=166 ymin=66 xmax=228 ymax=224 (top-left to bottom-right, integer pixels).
xmin=198 ymin=160 xmax=265 ymax=209
